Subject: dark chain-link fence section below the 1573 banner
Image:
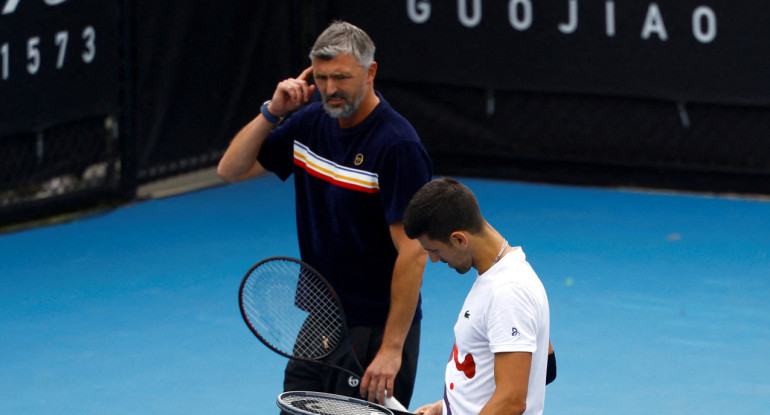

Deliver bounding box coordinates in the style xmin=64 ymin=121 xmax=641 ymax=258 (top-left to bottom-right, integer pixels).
xmin=0 ymin=115 xmax=120 ymax=228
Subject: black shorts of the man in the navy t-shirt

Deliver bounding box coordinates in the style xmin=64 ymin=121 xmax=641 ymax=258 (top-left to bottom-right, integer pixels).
xmin=283 ymin=322 xmax=420 ymax=407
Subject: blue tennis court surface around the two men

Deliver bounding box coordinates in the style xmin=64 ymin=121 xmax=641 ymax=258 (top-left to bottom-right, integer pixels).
xmin=0 ymin=177 xmax=770 ymax=415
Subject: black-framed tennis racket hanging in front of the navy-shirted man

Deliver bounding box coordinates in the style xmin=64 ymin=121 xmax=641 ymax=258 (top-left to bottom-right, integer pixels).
xmin=238 ymin=257 xmax=406 ymax=411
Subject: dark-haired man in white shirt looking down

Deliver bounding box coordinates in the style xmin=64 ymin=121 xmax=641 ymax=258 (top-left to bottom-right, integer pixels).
xmin=404 ymin=178 xmax=555 ymax=415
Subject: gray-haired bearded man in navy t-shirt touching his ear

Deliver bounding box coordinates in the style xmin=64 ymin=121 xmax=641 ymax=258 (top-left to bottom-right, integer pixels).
xmin=218 ymin=22 xmax=432 ymax=405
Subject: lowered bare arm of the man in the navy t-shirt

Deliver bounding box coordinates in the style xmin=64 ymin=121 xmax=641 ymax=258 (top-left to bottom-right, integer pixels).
xmin=361 ymin=222 xmax=428 ymax=403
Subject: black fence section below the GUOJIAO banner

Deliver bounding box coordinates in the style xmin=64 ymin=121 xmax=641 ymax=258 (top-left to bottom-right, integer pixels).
xmin=380 ymin=83 xmax=770 ymax=195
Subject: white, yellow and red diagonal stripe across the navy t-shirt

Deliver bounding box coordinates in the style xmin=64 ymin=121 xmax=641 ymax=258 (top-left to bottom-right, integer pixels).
xmin=294 ymin=141 xmax=380 ymax=193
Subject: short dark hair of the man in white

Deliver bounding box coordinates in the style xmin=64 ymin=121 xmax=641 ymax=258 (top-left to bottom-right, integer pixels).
xmin=404 ymin=177 xmax=484 ymax=242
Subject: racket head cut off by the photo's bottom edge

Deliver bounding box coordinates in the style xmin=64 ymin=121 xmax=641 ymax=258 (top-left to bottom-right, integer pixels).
xmin=276 ymin=391 xmax=393 ymax=415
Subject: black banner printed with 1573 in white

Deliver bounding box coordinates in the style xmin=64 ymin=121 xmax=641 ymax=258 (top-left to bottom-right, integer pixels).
xmin=0 ymin=0 xmax=121 ymax=134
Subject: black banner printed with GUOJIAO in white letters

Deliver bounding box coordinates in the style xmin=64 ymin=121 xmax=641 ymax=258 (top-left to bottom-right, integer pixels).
xmin=330 ymin=0 xmax=770 ymax=105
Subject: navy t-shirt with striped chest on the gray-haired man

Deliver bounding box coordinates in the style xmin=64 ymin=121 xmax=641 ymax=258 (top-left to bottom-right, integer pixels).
xmin=258 ymin=93 xmax=433 ymax=326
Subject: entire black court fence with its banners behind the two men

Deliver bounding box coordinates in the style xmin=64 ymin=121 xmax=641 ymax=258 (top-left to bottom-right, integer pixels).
xmin=0 ymin=0 xmax=770 ymax=225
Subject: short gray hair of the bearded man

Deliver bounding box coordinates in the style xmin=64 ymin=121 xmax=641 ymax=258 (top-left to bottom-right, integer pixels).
xmin=310 ymin=21 xmax=374 ymax=69
